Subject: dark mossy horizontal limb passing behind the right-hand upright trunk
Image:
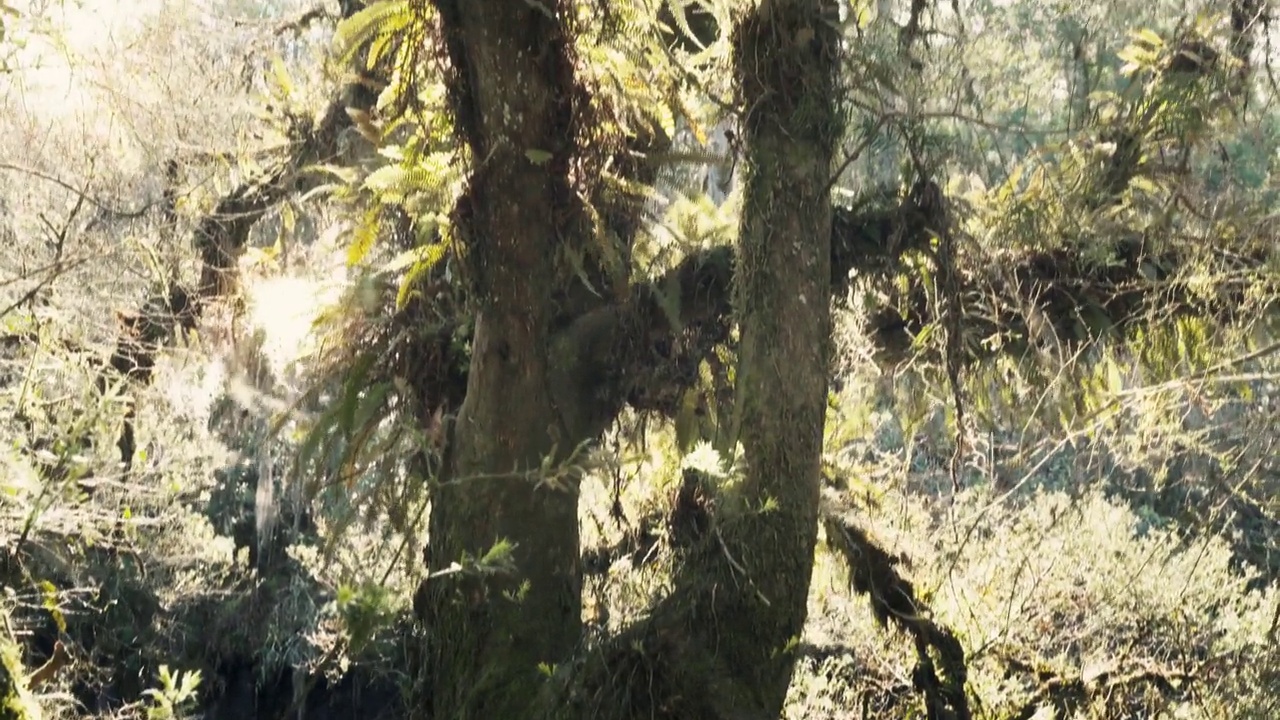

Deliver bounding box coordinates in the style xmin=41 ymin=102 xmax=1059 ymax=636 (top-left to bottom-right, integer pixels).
xmin=391 ymin=163 xmax=1267 ymax=425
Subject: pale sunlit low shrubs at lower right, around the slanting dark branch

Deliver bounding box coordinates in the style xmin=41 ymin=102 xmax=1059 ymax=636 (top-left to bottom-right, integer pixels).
xmin=787 ymin=481 xmax=1280 ymax=717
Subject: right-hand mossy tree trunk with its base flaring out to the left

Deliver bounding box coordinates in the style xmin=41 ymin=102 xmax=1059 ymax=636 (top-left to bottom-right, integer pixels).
xmin=545 ymin=0 xmax=841 ymax=720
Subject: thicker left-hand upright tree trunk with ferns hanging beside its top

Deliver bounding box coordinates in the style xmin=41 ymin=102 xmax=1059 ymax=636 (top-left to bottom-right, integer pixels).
xmin=417 ymin=0 xmax=581 ymax=720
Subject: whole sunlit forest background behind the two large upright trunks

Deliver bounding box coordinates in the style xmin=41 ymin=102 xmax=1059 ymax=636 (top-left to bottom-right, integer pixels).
xmin=0 ymin=0 xmax=1280 ymax=719
